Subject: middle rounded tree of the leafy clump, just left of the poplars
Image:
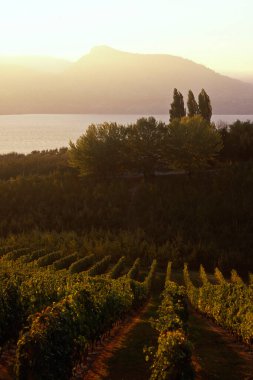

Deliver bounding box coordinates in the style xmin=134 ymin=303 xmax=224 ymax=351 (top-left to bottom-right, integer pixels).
xmin=127 ymin=117 xmax=167 ymax=178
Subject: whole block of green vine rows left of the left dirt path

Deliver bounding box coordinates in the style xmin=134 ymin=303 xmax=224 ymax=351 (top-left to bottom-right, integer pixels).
xmin=0 ymin=242 xmax=156 ymax=379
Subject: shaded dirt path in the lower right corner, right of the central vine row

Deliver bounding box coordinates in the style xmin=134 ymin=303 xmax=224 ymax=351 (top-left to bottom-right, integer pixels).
xmin=189 ymin=310 xmax=253 ymax=380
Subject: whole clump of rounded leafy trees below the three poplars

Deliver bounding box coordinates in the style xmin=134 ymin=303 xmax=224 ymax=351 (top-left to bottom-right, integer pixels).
xmin=69 ymin=115 xmax=222 ymax=177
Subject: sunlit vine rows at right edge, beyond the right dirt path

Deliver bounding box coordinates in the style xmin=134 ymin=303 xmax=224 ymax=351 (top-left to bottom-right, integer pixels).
xmin=184 ymin=265 xmax=253 ymax=344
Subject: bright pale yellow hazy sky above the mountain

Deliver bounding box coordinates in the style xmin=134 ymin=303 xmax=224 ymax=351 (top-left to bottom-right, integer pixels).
xmin=0 ymin=0 xmax=253 ymax=75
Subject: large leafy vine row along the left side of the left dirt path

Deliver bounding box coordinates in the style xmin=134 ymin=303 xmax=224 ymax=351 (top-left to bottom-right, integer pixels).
xmin=16 ymin=257 xmax=156 ymax=380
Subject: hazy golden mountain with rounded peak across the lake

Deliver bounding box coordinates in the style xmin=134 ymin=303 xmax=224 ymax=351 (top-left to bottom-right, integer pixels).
xmin=0 ymin=46 xmax=253 ymax=114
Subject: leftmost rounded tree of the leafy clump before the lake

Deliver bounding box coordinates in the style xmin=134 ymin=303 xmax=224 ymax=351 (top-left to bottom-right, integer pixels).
xmin=69 ymin=123 xmax=127 ymax=177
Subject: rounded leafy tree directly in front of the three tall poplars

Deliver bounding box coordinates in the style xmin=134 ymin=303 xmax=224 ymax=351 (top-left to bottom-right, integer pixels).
xmin=167 ymin=115 xmax=222 ymax=172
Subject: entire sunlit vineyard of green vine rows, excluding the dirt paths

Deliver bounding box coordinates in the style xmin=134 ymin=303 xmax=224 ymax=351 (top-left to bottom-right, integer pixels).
xmin=0 ymin=243 xmax=253 ymax=380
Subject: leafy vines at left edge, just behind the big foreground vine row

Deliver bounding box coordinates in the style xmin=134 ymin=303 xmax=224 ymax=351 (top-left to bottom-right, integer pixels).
xmin=0 ymin=256 xmax=71 ymax=345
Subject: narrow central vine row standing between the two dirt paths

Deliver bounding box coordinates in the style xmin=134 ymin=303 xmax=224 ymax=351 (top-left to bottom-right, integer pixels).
xmin=144 ymin=263 xmax=194 ymax=380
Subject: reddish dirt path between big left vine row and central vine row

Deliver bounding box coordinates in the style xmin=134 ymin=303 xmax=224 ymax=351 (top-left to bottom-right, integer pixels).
xmin=83 ymin=275 xmax=164 ymax=380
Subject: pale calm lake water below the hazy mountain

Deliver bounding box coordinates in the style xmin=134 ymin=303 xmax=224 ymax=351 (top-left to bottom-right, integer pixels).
xmin=0 ymin=114 xmax=253 ymax=154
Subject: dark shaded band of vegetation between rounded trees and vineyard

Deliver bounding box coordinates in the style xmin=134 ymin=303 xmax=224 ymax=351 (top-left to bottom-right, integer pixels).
xmin=0 ymin=163 xmax=253 ymax=273
